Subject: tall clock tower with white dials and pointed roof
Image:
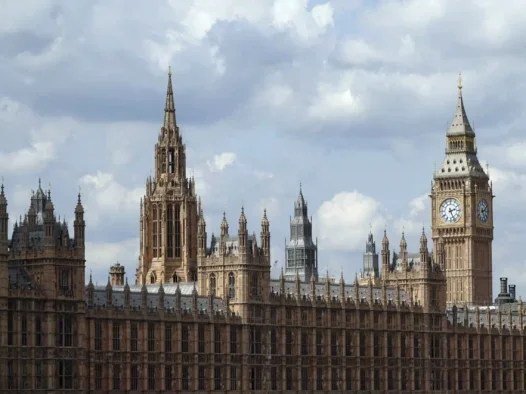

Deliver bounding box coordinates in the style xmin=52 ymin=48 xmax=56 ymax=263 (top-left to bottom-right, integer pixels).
xmin=430 ymin=77 xmax=493 ymax=306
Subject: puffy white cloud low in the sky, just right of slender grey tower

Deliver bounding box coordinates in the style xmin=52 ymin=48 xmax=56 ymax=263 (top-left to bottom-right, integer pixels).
xmin=316 ymin=191 xmax=386 ymax=250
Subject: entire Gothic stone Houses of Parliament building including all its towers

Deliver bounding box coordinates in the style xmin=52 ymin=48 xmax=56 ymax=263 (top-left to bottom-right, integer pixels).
xmin=0 ymin=73 xmax=526 ymax=394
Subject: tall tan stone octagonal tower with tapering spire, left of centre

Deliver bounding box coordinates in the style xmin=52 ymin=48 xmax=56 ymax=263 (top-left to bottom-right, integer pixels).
xmin=136 ymin=67 xmax=197 ymax=285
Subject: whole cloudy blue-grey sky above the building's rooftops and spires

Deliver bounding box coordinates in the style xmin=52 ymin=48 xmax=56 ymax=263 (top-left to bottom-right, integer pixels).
xmin=0 ymin=0 xmax=526 ymax=294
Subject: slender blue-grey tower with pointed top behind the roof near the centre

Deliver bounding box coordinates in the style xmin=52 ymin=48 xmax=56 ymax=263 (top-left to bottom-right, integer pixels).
xmin=285 ymin=185 xmax=318 ymax=282
